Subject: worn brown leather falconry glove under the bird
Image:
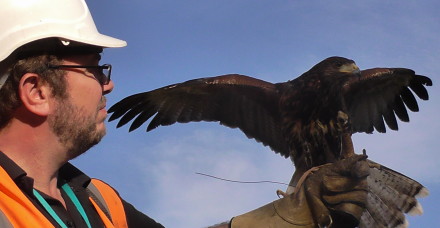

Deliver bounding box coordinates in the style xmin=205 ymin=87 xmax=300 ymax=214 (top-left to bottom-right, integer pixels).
xmin=231 ymin=155 xmax=369 ymax=228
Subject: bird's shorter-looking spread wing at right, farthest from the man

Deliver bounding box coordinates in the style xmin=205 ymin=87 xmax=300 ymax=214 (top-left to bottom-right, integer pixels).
xmin=343 ymin=68 xmax=432 ymax=133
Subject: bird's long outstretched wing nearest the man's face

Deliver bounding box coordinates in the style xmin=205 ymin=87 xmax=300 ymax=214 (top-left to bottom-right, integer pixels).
xmin=109 ymin=74 xmax=289 ymax=157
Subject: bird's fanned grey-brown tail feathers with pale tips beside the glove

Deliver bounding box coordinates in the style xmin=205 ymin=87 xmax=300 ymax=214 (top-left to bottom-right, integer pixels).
xmin=359 ymin=160 xmax=429 ymax=228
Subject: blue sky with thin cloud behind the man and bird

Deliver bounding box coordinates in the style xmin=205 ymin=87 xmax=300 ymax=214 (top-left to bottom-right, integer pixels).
xmin=74 ymin=0 xmax=440 ymax=228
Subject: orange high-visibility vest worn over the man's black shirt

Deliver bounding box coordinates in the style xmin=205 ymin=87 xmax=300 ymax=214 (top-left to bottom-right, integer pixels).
xmin=0 ymin=167 xmax=128 ymax=228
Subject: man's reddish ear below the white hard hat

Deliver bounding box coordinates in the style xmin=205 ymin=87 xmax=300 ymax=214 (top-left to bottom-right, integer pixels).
xmin=18 ymin=73 xmax=52 ymax=116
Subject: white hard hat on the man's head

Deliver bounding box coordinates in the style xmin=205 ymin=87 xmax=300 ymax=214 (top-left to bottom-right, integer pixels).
xmin=0 ymin=0 xmax=127 ymax=62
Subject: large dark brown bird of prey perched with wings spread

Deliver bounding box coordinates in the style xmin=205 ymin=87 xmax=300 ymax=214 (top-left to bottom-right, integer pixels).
xmin=109 ymin=57 xmax=432 ymax=227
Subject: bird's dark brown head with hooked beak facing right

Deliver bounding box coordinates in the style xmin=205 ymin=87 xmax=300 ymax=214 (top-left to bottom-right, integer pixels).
xmin=310 ymin=56 xmax=361 ymax=76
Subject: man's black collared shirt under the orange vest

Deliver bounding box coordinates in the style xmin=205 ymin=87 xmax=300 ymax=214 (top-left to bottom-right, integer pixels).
xmin=0 ymin=151 xmax=163 ymax=228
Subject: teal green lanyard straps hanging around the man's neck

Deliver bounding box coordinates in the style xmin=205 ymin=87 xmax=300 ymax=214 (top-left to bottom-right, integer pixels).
xmin=33 ymin=183 xmax=92 ymax=228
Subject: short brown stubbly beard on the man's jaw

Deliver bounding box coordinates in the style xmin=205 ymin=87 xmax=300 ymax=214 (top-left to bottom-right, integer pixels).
xmin=48 ymin=97 xmax=106 ymax=160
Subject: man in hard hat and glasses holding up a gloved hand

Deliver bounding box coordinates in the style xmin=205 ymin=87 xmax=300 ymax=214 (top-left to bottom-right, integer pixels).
xmin=0 ymin=0 xmax=368 ymax=227
